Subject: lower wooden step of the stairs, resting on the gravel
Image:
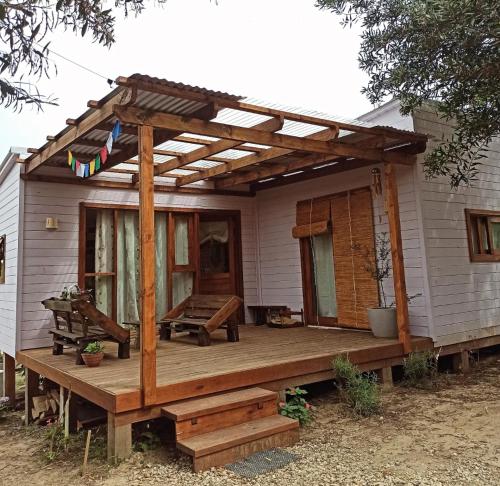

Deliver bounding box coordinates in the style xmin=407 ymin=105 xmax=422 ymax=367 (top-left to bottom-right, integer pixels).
xmin=177 ymin=415 xmax=299 ymax=472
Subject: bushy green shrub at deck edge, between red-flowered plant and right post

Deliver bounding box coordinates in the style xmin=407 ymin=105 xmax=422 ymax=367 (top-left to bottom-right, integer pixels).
xmin=332 ymin=357 xmax=380 ymax=417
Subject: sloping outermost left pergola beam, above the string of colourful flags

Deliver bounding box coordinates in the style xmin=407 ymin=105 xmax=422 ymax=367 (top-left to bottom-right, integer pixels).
xmin=26 ymin=92 xmax=131 ymax=174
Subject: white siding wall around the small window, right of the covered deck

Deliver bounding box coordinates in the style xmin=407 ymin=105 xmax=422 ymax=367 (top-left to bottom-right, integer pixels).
xmin=414 ymin=110 xmax=500 ymax=345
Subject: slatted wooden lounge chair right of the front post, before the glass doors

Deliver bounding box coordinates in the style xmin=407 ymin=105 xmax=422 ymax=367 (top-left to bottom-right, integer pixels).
xmin=160 ymin=294 xmax=243 ymax=346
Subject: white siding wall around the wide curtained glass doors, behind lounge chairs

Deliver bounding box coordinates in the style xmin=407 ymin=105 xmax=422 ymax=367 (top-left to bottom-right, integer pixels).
xmin=21 ymin=181 xmax=257 ymax=349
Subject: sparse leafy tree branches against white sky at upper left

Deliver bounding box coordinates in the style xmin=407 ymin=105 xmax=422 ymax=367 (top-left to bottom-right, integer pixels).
xmin=0 ymin=0 xmax=166 ymax=109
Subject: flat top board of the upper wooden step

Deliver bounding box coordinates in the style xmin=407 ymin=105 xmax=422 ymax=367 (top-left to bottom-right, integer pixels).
xmin=161 ymin=388 xmax=277 ymax=421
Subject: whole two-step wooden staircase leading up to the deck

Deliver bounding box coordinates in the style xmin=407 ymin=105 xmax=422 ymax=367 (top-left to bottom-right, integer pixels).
xmin=162 ymin=388 xmax=299 ymax=472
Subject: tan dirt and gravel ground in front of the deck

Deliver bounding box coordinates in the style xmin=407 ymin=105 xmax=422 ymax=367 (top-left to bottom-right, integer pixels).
xmin=0 ymin=361 xmax=500 ymax=486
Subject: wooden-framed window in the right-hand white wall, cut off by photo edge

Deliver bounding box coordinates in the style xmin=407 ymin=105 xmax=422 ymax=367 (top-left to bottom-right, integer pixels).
xmin=465 ymin=209 xmax=500 ymax=262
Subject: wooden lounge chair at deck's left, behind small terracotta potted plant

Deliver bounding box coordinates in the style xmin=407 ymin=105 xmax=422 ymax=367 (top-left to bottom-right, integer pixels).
xmin=42 ymin=297 xmax=130 ymax=365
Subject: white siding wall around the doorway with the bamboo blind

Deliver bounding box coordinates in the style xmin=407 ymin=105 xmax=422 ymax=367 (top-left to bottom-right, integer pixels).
xmin=257 ymin=163 xmax=430 ymax=336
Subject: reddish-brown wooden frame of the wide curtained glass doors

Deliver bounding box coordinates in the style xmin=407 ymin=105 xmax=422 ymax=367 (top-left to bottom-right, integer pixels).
xmin=78 ymin=202 xmax=244 ymax=322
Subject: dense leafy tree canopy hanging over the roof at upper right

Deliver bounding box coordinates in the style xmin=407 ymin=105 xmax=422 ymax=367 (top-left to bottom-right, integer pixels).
xmin=317 ymin=0 xmax=500 ymax=187
